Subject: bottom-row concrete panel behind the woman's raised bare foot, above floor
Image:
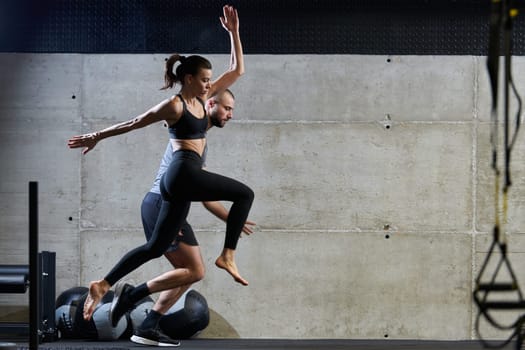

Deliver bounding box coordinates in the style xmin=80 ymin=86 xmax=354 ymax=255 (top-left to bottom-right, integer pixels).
xmin=198 ymin=230 xmax=472 ymax=339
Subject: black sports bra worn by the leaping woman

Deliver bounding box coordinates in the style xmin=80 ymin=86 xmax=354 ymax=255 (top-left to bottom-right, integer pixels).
xmin=168 ymin=94 xmax=208 ymax=140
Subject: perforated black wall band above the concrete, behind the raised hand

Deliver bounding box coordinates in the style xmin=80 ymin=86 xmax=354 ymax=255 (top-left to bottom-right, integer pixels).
xmin=0 ymin=0 xmax=525 ymax=55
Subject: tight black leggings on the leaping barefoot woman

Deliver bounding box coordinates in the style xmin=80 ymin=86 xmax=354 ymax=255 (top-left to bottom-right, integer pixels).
xmin=104 ymin=150 xmax=254 ymax=285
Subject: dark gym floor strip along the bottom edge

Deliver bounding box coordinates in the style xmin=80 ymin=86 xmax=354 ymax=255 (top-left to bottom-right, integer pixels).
xmin=0 ymin=339 xmax=516 ymax=350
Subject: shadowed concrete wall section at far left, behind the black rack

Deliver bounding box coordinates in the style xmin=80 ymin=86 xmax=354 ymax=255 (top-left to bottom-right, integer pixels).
xmin=0 ymin=54 xmax=82 ymax=304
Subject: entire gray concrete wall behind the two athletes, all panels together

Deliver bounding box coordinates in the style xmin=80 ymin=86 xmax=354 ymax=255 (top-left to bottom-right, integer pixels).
xmin=0 ymin=54 xmax=525 ymax=339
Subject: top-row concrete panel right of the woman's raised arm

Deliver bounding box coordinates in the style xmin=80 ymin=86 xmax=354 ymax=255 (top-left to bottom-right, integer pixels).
xmin=234 ymin=55 xmax=477 ymax=122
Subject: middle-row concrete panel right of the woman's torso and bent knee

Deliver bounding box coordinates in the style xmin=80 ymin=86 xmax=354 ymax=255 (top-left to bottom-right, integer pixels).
xmin=201 ymin=121 xmax=472 ymax=231
